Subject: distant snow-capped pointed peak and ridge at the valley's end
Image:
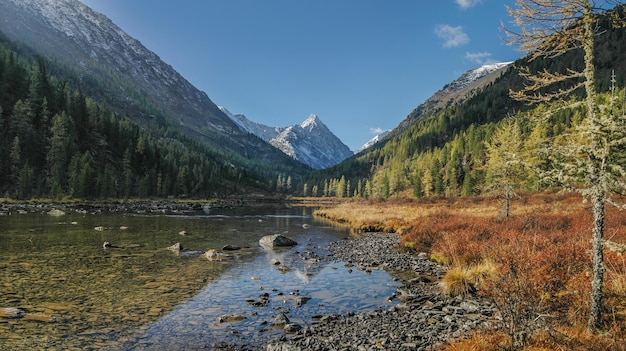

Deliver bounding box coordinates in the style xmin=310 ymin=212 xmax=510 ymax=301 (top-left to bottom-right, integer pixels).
xmin=219 ymin=106 xmax=353 ymax=169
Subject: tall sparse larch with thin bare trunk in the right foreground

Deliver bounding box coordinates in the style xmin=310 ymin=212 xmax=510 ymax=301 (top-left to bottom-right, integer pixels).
xmin=508 ymin=0 xmax=626 ymax=333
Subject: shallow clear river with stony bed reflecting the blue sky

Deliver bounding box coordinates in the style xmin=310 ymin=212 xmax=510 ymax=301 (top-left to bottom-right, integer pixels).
xmin=0 ymin=207 xmax=399 ymax=350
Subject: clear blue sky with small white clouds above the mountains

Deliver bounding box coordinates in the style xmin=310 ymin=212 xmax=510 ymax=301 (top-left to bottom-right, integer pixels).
xmin=81 ymin=0 xmax=522 ymax=149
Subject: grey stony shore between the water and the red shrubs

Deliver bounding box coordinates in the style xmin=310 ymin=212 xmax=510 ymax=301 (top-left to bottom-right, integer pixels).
xmin=266 ymin=233 xmax=498 ymax=351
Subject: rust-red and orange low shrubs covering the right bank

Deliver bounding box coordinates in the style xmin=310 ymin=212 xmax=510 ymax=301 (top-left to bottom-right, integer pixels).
xmin=402 ymin=197 xmax=626 ymax=350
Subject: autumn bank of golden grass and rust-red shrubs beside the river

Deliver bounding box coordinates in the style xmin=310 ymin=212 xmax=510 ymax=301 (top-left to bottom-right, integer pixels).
xmin=316 ymin=194 xmax=626 ymax=351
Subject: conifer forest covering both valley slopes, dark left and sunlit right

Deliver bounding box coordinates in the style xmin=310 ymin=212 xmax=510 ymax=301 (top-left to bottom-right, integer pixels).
xmin=0 ymin=4 xmax=626 ymax=205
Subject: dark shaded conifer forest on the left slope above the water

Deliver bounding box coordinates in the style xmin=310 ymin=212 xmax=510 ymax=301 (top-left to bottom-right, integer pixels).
xmin=0 ymin=41 xmax=271 ymax=199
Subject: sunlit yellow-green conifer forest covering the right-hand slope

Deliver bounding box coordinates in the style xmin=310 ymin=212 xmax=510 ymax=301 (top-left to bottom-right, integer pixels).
xmin=298 ymin=7 xmax=626 ymax=199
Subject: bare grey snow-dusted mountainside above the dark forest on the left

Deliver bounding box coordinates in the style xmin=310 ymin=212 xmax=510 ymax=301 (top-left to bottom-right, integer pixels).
xmin=0 ymin=0 xmax=306 ymax=173
